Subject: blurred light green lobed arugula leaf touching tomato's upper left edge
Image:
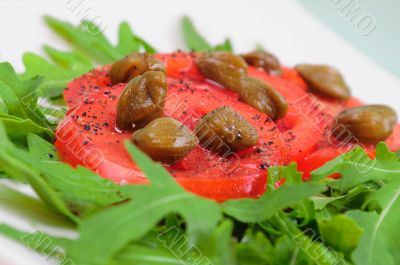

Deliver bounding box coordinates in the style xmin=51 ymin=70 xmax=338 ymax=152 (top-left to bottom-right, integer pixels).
xmin=21 ymin=46 xmax=93 ymax=97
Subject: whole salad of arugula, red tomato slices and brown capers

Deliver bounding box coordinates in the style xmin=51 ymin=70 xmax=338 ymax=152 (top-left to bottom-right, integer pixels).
xmin=0 ymin=16 xmax=400 ymax=265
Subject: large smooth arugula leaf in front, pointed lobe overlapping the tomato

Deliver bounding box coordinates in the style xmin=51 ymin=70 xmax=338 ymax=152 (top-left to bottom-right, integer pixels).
xmin=68 ymin=142 xmax=222 ymax=264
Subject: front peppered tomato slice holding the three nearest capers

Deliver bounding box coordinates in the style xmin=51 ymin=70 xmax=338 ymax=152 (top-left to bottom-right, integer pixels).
xmin=56 ymin=72 xmax=289 ymax=201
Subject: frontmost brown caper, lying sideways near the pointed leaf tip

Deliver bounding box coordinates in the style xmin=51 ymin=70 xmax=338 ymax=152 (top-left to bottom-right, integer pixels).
xmin=132 ymin=117 xmax=199 ymax=163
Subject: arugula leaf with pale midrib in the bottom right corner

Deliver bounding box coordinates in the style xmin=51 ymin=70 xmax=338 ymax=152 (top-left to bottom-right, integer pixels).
xmin=347 ymin=177 xmax=400 ymax=265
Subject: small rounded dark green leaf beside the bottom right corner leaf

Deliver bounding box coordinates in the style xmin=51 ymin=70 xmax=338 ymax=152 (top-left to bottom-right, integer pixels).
xmin=317 ymin=215 xmax=363 ymax=259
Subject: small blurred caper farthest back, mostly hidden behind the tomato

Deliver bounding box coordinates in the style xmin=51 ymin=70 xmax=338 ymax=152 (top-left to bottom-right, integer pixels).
xmin=242 ymin=51 xmax=282 ymax=75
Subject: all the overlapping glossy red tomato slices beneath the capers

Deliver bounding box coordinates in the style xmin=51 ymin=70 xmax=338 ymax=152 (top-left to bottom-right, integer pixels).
xmin=56 ymin=52 xmax=400 ymax=201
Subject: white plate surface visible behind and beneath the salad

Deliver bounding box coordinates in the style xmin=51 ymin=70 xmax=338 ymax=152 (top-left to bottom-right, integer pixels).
xmin=0 ymin=0 xmax=400 ymax=265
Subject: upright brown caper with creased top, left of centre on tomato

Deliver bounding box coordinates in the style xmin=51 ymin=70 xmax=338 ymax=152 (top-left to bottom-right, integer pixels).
xmin=116 ymin=71 xmax=167 ymax=131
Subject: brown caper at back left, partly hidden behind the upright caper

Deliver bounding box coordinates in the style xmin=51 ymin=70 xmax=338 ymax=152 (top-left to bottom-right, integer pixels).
xmin=110 ymin=53 xmax=165 ymax=85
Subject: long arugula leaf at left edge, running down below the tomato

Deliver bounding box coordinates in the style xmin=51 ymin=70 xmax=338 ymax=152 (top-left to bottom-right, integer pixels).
xmin=0 ymin=127 xmax=127 ymax=221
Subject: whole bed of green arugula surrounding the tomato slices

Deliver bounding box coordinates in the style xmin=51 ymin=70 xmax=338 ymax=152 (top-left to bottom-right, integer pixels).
xmin=0 ymin=17 xmax=400 ymax=265
